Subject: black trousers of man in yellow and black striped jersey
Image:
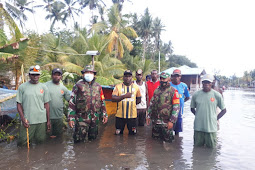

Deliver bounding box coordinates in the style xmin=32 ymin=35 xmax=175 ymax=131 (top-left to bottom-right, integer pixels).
xmin=115 ymin=117 xmax=136 ymax=135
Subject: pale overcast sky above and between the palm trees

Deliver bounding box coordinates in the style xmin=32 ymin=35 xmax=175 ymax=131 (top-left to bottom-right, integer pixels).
xmin=0 ymin=0 xmax=255 ymax=76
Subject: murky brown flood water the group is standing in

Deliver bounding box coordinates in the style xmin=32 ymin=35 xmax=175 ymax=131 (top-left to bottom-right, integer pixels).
xmin=0 ymin=90 xmax=255 ymax=170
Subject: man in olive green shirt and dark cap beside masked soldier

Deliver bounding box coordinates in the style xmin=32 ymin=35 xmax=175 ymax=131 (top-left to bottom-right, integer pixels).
xmin=45 ymin=68 xmax=70 ymax=138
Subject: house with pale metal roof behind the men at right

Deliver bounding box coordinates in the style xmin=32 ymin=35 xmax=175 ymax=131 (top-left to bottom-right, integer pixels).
xmin=164 ymin=65 xmax=206 ymax=92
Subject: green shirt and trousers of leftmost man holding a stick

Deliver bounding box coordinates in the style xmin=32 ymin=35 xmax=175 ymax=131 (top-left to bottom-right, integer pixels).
xmin=16 ymin=82 xmax=50 ymax=145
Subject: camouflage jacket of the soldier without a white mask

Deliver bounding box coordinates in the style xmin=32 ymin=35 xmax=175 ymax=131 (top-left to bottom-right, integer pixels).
xmin=148 ymin=84 xmax=180 ymax=124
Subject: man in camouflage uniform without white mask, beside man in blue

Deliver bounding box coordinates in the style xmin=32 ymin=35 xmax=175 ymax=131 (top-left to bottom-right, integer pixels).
xmin=146 ymin=72 xmax=180 ymax=142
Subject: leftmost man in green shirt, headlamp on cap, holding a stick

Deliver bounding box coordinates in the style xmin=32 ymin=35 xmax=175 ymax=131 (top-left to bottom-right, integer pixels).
xmin=16 ymin=65 xmax=51 ymax=146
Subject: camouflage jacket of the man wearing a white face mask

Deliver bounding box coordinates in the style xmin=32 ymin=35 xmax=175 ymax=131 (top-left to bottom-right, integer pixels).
xmin=68 ymin=80 xmax=108 ymax=121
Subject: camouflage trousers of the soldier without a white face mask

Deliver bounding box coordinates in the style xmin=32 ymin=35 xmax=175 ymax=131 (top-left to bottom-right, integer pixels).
xmin=152 ymin=124 xmax=174 ymax=143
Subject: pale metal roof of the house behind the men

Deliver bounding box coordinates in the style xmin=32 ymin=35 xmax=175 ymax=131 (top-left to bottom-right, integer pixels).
xmin=163 ymin=65 xmax=206 ymax=75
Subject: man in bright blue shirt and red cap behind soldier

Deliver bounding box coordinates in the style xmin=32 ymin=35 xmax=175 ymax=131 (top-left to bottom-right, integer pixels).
xmin=170 ymin=69 xmax=190 ymax=135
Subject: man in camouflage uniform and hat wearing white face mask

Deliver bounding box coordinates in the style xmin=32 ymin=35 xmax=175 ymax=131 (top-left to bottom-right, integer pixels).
xmin=68 ymin=65 xmax=108 ymax=142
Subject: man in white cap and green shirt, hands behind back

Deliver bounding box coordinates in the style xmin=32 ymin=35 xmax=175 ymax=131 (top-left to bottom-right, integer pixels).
xmin=190 ymin=74 xmax=226 ymax=148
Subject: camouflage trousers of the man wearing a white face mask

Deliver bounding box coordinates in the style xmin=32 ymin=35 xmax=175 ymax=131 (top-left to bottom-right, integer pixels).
xmin=73 ymin=113 xmax=99 ymax=142
